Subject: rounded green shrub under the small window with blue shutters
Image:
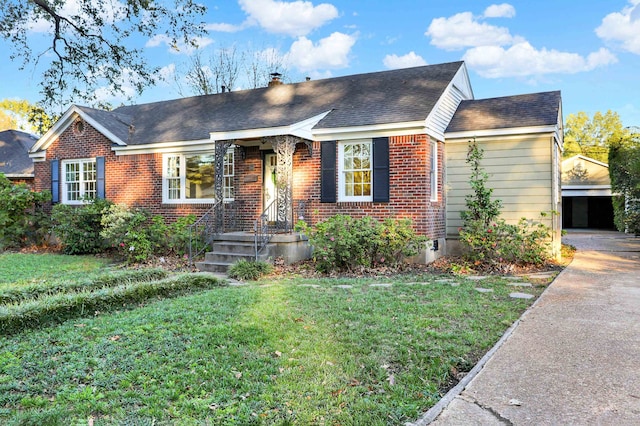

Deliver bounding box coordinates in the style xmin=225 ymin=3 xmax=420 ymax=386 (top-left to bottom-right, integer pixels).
xmin=51 ymin=199 xmax=112 ymax=254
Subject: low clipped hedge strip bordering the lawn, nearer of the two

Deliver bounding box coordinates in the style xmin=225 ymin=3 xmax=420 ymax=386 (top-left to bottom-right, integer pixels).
xmin=0 ymin=274 xmax=226 ymax=335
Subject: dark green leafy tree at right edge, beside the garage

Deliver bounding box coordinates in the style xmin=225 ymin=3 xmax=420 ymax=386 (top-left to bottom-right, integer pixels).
xmin=609 ymin=128 xmax=640 ymax=235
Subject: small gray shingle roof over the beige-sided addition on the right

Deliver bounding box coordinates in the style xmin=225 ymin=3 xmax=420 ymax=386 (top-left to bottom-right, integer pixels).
xmin=446 ymin=91 xmax=561 ymax=133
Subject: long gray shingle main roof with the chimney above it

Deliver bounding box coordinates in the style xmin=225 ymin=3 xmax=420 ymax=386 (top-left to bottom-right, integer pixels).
xmin=107 ymin=62 xmax=462 ymax=145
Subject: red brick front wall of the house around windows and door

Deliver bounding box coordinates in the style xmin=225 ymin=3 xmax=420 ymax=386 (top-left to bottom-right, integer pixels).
xmin=35 ymin=118 xmax=445 ymax=238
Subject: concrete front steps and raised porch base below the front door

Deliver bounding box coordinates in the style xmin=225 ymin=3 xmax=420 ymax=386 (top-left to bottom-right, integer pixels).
xmin=196 ymin=232 xmax=311 ymax=273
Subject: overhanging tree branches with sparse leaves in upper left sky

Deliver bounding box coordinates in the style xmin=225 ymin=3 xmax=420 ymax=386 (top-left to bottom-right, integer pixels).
xmin=0 ymin=0 xmax=206 ymax=106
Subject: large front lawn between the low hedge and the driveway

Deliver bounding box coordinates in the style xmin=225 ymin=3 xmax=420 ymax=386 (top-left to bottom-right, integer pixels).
xmin=0 ymin=253 xmax=543 ymax=425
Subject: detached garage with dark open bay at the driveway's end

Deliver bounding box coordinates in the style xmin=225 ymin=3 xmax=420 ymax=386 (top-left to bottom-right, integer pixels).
xmin=562 ymin=155 xmax=615 ymax=229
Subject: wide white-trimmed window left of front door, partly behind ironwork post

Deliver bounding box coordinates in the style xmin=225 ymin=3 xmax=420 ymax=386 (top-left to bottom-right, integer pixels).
xmin=162 ymin=148 xmax=234 ymax=203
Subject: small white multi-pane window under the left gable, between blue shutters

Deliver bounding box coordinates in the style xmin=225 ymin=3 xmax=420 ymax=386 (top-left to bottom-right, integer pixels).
xmin=62 ymin=158 xmax=97 ymax=204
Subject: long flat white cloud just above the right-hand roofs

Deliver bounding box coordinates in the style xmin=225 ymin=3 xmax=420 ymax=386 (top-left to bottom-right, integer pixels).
xmin=463 ymin=41 xmax=617 ymax=78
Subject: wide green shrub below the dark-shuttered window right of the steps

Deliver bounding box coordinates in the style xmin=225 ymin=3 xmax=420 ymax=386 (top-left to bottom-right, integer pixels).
xmin=297 ymin=215 xmax=425 ymax=272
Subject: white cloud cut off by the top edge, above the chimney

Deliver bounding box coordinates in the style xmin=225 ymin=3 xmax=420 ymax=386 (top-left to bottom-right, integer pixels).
xmin=239 ymin=0 xmax=338 ymax=37
